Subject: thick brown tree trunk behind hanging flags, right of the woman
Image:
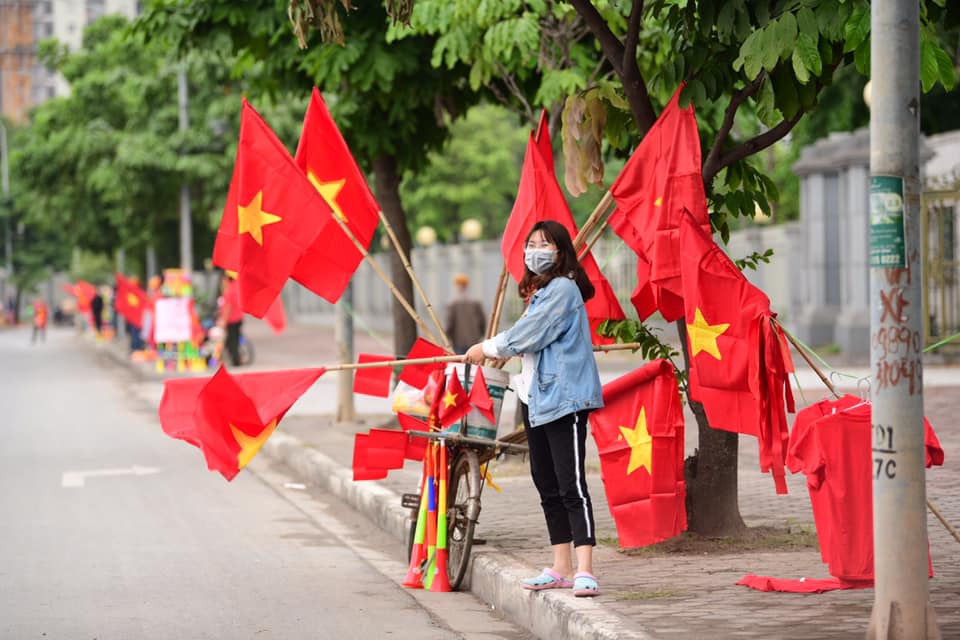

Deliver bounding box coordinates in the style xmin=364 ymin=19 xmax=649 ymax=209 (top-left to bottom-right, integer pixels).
xmin=677 ymin=320 xmax=746 ymax=536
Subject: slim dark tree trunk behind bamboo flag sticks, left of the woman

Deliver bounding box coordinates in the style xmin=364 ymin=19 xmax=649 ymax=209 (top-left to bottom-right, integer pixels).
xmin=373 ymin=155 xmax=417 ymax=356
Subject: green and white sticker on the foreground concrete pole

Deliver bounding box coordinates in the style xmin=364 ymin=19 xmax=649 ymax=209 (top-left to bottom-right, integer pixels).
xmin=870 ymin=176 xmax=907 ymax=269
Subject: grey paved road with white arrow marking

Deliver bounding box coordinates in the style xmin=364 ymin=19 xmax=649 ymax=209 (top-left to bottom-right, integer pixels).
xmin=0 ymin=330 xmax=528 ymax=640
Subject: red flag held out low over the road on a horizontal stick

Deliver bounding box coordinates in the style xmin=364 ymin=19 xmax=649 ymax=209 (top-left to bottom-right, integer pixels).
xmin=157 ymin=367 xmax=324 ymax=480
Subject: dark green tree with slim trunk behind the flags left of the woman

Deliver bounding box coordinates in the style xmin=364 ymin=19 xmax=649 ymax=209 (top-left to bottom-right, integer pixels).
xmin=139 ymin=0 xmax=480 ymax=353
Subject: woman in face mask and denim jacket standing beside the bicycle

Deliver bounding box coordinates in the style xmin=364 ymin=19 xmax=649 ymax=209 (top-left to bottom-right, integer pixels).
xmin=466 ymin=220 xmax=603 ymax=596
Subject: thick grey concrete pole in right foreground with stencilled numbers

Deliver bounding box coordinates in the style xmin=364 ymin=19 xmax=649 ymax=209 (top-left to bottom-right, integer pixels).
xmin=867 ymin=0 xmax=940 ymax=640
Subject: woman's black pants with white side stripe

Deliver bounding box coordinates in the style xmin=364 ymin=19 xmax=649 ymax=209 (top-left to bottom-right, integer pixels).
xmin=520 ymin=403 xmax=597 ymax=547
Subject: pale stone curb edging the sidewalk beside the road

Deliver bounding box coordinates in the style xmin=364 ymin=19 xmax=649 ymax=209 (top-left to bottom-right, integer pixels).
xmin=261 ymin=431 xmax=652 ymax=640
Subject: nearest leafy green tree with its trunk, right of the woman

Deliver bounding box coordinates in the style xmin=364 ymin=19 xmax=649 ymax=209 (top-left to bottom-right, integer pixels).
xmin=348 ymin=0 xmax=956 ymax=533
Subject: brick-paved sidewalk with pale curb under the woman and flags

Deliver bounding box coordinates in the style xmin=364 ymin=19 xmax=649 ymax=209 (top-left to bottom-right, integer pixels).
xmin=120 ymin=321 xmax=960 ymax=640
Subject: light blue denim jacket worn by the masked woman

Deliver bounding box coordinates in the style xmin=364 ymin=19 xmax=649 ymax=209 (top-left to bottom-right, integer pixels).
xmin=493 ymin=278 xmax=603 ymax=427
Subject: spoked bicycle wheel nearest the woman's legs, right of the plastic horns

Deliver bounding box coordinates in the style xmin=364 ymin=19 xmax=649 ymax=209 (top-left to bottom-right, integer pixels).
xmin=447 ymin=449 xmax=480 ymax=590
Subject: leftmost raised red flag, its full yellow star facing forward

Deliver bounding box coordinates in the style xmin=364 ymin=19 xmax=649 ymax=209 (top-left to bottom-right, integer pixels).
xmin=213 ymin=99 xmax=333 ymax=318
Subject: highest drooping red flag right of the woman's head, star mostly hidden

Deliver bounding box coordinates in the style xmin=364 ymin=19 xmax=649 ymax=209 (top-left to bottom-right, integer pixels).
xmin=609 ymin=84 xmax=710 ymax=321
